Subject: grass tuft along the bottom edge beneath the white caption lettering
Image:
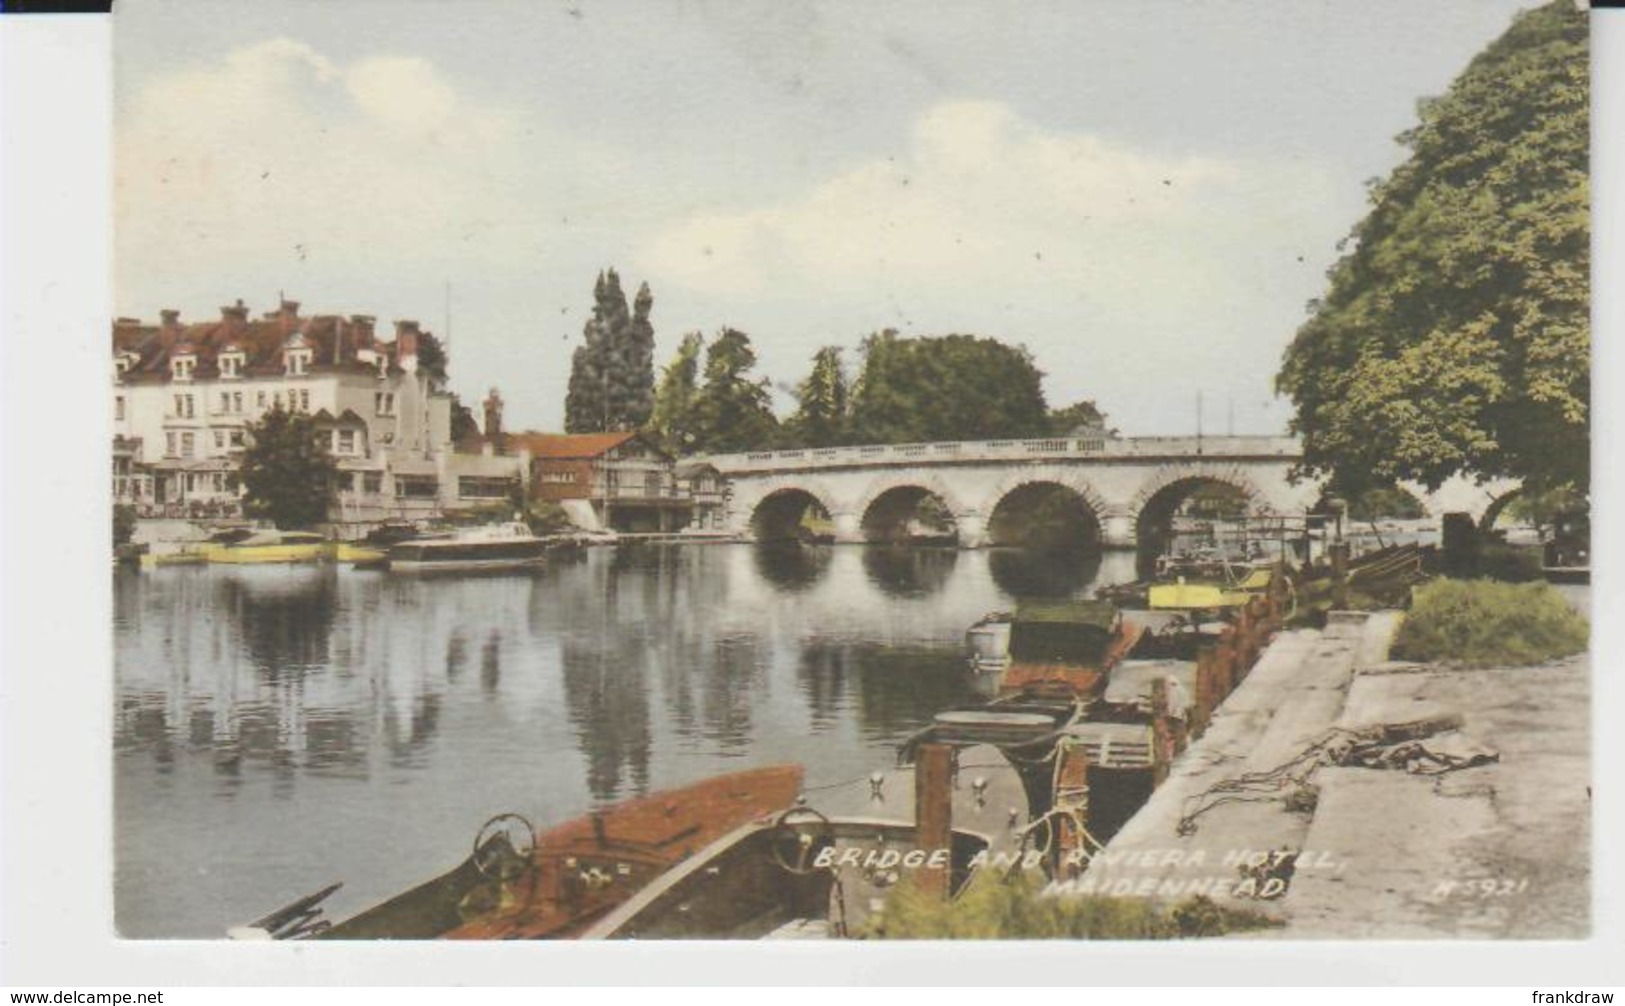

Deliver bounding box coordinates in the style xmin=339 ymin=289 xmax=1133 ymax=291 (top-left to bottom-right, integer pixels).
xmin=865 ymin=869 xmax=1281 ymax=939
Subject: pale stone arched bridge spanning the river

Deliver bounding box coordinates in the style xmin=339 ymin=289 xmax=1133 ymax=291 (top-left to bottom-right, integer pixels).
xmin=704 ymin=436 xmax=1516 ymax=548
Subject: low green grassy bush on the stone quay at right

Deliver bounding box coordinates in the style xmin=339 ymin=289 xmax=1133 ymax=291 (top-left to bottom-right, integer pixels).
xmin=1393 ymin=580 xmax=1591 ymax=666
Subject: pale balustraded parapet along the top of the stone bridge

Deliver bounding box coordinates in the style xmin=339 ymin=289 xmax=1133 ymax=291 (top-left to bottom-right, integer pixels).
xmin=702 ymin=437 xmax=1300 ymax=475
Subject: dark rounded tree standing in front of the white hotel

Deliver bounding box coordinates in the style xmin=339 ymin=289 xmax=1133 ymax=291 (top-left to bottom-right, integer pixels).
xmin=241 ymin=406 xmax=338 ymax=528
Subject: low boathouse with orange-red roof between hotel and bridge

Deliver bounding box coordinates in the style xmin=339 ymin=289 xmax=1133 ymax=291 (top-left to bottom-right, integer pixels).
xmin=507 ymin=432 xmax=694 ymax=531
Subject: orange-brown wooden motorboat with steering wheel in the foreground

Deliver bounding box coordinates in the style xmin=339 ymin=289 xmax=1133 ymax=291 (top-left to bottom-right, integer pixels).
xmin=232 ymin=765 xmax=803 ymax=939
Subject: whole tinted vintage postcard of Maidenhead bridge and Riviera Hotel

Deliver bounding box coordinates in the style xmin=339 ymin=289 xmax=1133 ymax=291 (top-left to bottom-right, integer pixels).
xmin=104 ymin=0 xmax=1594 ymax=944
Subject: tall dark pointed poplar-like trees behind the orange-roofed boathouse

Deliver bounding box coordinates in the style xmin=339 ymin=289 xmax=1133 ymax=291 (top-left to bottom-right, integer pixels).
xmin=564 ymin=270 xmax=655 ymax=432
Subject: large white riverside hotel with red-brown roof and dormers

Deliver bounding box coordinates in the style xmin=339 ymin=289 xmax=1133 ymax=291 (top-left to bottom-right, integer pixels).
xmin=112 ymin=299 xmax=525 ymax=522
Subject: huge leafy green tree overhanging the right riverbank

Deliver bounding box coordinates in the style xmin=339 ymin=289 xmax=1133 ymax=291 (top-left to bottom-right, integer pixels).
xmin=1277 ymin=0 xmax=1591 ymax=494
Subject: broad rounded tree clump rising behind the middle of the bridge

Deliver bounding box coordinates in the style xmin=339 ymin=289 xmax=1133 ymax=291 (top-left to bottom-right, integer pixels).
xmin=852 ymin=330 xmax=1050 ymax=444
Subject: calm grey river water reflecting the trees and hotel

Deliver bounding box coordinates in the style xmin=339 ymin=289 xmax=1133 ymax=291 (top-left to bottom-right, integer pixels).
xmin=114 ymin=544 xmax=1134 ymax=938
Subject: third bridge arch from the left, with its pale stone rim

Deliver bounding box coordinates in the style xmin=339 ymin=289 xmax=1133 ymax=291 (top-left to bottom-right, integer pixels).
xmin=960 ymin=465 xmax=1112 ymax=551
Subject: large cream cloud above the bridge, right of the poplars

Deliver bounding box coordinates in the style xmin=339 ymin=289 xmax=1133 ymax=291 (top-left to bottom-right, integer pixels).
xmin=639 ymin=101 xmax=1347 ymax=429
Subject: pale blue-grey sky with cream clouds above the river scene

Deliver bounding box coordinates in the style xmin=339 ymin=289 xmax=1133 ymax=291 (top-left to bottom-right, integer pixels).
xmin=114 ymin=0 xmax=1531 ymax=436
